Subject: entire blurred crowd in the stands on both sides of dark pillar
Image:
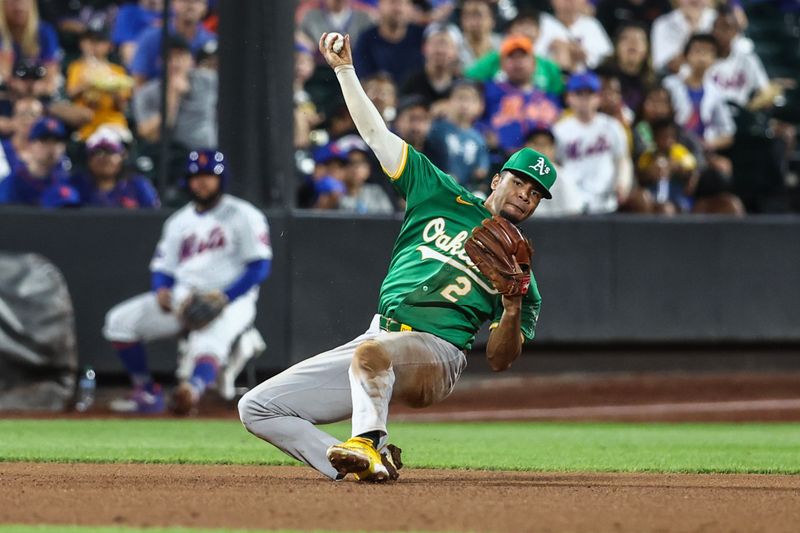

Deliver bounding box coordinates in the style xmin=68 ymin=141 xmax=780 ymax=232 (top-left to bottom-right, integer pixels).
xmin=0 ymin=0 xmax=800 ymax=216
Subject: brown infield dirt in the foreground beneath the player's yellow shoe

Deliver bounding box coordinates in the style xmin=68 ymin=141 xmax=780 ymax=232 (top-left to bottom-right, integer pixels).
xmin=0 ymin=463 xmax=800 ymax=533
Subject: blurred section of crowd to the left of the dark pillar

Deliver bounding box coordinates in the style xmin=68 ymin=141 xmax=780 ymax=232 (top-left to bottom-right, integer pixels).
xmin=0 ymin=0 xmax=217 ymax=208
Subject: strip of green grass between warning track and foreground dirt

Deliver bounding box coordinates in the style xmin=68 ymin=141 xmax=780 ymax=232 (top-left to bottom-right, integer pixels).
xmin=0 ymin=420 xmax=800 ymax=474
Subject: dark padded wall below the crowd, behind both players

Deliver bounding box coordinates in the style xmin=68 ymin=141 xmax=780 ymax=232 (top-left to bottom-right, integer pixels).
xmin=0 ymin=208 xmax=800 ymax=371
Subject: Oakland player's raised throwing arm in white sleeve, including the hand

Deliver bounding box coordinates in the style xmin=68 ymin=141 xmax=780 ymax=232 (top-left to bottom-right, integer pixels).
xmin=319 ymin=33 xmax=405 ymax=179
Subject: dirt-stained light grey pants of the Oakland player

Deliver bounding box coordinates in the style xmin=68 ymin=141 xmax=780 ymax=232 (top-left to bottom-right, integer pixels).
xmin=239 ymin=315 xmax=467 ymax=479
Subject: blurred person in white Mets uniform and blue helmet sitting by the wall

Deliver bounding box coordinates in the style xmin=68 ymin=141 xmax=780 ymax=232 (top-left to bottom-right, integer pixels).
xmin=103 ymin=150 xmax=272 ymax=415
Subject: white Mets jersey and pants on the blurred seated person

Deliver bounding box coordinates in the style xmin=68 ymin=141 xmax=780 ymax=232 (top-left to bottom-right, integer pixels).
xmin=103 ymin=195 xmax=272 ymax=364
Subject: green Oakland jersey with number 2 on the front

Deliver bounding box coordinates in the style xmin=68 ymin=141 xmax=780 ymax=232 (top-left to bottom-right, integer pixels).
xmin=379 ymin=144 xmax=541 ymax=349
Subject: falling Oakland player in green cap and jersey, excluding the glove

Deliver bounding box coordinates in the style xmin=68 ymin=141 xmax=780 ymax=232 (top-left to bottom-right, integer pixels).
xmin=239 ymin=34 xmax=556 ymax=482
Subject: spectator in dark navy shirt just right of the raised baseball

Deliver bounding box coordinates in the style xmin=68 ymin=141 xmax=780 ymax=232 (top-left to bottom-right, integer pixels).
xmin=353 ymin=0 xmax=424 ymax=87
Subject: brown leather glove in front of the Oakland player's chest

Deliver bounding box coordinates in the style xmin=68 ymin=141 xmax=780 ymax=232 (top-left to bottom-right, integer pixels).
xmin=464 ymin=215 xmax=533 ymax=296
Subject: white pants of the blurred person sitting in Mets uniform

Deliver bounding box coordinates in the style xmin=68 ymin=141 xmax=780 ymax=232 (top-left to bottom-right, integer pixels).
xmin=103 ymin=292 xmax=257 ymax=365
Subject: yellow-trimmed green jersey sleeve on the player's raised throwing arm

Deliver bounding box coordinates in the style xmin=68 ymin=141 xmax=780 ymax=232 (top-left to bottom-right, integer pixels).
xmin=383 ymin=143 xmax=456 ymax=208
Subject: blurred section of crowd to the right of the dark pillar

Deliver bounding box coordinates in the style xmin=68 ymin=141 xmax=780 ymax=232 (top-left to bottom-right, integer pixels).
xmin=294 ymin=0 xmax=800 ymax=216
